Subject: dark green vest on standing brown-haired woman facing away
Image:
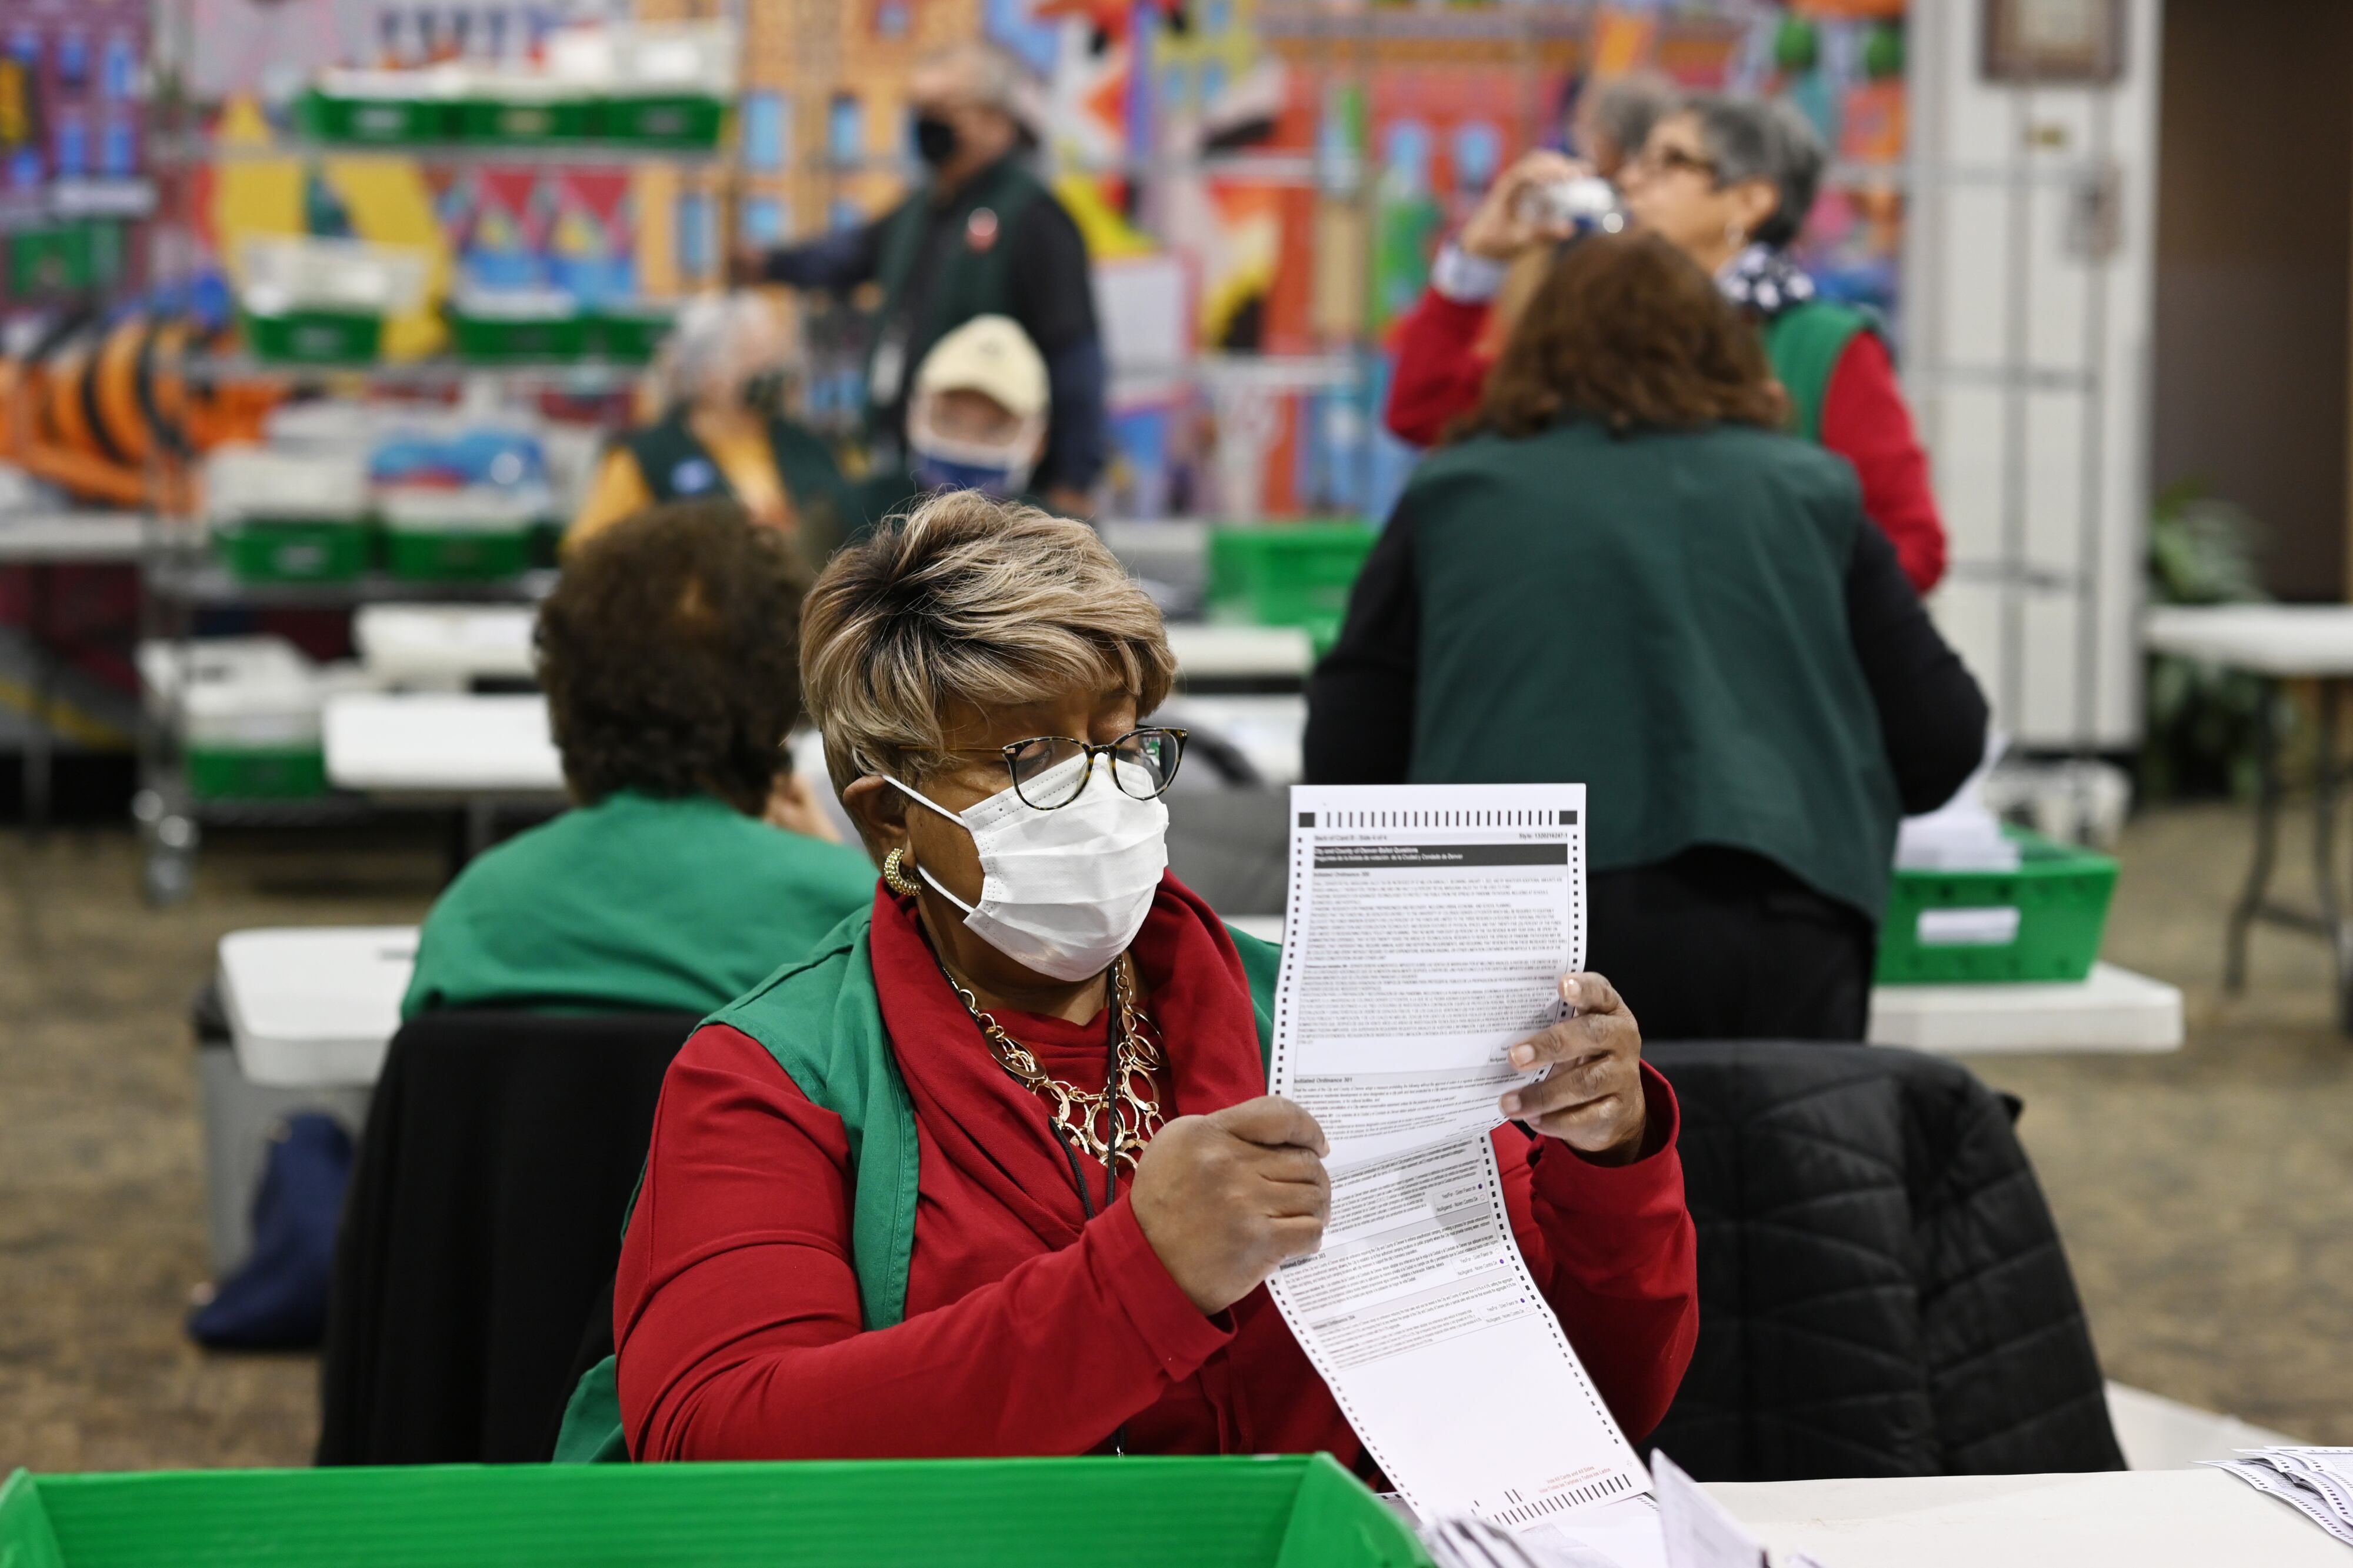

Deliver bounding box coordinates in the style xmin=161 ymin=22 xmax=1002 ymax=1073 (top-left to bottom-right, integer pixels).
xmin=1391 ymin=419 xmax=1899 ymax=925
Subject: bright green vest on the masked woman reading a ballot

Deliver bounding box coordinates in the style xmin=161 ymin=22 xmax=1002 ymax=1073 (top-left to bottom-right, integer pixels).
xmin=555 ymin=906 xmax=1282 ymax=1464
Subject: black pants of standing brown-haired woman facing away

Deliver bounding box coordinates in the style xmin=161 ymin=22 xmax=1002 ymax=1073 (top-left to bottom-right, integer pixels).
xmin=1586 ymin=848 xmax=1878 ymax=1040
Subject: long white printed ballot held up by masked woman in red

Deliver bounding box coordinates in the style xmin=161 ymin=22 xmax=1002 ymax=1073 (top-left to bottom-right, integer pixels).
xmin=1268 ymin=784 xmax=1647 ymax=1528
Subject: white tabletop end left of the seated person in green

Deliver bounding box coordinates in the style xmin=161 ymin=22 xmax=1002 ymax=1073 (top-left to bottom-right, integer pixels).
xmin=221 ymin=925 xmax=416 ymax=1087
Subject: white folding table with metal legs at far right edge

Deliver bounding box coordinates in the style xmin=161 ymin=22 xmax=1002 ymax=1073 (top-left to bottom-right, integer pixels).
xmin=2141 ymin=605 xmax=2353 ymax=1033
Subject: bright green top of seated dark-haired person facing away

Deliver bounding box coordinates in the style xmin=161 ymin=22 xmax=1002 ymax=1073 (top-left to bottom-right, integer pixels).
xmin=400 ymin=791 xmax=875 ymax=1017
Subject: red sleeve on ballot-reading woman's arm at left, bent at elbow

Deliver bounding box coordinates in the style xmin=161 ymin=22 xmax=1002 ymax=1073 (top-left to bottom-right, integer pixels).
xmin=614 ymin=1024 xmax=1228 ymax=1460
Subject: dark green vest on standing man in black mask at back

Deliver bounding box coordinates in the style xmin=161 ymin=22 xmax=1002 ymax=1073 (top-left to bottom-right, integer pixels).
xmin=866 ymin=158 xmax=1054 ymax=426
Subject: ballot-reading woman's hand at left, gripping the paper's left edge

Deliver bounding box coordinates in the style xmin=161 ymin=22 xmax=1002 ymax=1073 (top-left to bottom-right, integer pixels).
xmin=1127 ymin=1095 xmax=1332 ymax=1314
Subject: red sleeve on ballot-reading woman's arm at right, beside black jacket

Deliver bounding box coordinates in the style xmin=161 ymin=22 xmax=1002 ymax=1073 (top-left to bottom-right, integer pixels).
xmin=1504 ymin=1062 xmax=1699 ymax=1441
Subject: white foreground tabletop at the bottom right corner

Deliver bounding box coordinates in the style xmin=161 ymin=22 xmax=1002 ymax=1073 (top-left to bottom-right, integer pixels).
xmin=1708 ymin=1469 xmax=2353 ymax=1568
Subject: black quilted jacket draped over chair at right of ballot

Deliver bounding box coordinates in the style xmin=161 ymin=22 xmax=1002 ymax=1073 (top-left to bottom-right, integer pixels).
xmin=1645 ymin=1043 xmax=2125 ymax=1481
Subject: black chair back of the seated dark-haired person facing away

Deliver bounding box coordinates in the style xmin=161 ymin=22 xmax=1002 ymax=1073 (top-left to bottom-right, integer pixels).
xmin=318 ymin=1010 xmax=699 ymax=1464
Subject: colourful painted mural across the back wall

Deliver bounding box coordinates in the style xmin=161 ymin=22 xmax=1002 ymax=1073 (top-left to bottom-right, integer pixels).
xmin=184 ymin=0 xmax=1906 ymax=516
